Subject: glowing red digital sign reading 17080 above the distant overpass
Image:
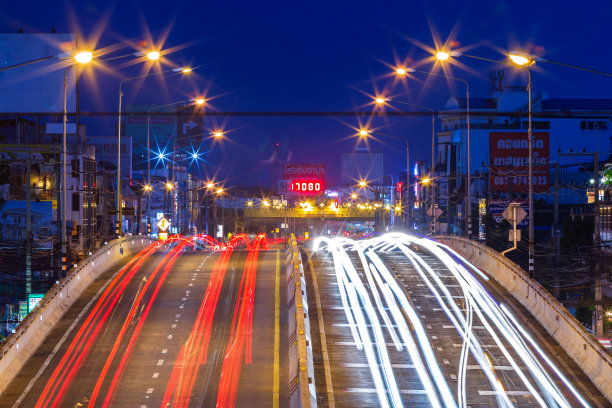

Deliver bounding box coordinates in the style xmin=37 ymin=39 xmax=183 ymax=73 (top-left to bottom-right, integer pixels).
xmin=278 ymin=163 xmax=325 ymax=195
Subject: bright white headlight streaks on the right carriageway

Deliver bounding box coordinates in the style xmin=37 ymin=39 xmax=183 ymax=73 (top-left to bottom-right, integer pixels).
xmin=313 ymin=233 xmax=589 ymax=408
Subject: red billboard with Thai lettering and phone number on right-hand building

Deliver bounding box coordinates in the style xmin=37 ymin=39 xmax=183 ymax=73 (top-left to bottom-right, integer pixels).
xmin=489 ymin=132 xmax=550 ymax=193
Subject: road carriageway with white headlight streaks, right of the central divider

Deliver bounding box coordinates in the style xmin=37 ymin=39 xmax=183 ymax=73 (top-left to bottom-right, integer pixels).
xmin=303 ymin=235 xmax=609 ymax=407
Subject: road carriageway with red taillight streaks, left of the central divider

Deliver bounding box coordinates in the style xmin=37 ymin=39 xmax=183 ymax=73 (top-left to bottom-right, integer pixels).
xmin=0 ymin=236 xmax=288 ymax=408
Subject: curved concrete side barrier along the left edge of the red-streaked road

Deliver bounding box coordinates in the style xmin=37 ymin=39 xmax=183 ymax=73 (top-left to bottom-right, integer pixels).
xmin=0 ymin=236 xmax=155 ymax=395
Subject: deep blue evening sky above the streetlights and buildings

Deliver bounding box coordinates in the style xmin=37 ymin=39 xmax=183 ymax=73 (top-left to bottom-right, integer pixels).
xmin=0 ymin=0 xmax=612 ymax=188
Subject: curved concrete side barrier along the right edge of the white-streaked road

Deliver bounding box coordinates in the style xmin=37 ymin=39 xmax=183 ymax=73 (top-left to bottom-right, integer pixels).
xmin=434 ymin=236 xmax=612 ymax=402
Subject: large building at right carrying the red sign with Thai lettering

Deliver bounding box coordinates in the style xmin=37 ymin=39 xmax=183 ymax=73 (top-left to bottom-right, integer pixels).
xmin=435 ymin=71 xmax=612 ymax=233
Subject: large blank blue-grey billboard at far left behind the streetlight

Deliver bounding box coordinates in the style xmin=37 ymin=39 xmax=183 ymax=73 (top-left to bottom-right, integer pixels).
xmin=0 ymin=33 xmax=76 ymax=113
